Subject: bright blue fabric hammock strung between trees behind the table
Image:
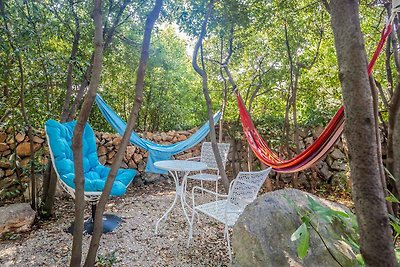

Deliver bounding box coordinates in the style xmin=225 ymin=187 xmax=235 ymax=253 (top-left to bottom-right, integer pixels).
xmin=96 ymin=95 xmax=221 ymax=174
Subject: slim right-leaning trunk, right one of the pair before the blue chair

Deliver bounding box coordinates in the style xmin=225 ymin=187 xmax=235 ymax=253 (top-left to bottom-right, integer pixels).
xmin=84 ymin=0 xmax=163 ymax=267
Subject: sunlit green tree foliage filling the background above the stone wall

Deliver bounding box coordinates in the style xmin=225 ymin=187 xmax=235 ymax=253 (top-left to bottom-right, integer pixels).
xmin=0 ymin=0 xmax=394 ymax=153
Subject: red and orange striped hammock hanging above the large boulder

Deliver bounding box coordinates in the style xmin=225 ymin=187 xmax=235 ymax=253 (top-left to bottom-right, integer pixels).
xmin=237 ymin=24 xmax=392 ymax=173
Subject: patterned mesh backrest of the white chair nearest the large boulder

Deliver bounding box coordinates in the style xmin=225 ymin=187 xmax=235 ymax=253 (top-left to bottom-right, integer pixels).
xmin=228 ymin=168 xmax=271 ymax=210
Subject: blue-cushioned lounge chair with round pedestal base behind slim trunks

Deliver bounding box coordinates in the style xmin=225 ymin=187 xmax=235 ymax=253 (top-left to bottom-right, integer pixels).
xmin=45 ymin=120 xmax=137 ymax=233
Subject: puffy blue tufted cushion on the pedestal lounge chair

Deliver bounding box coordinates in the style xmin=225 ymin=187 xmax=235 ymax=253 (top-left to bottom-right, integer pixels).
xmin=45 ymin=120 xmax=137 ymax=196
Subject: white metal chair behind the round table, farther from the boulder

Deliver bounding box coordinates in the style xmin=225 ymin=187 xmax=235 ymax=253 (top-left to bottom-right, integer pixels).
xmin=187 ymin=142 xmax=230 ymax=197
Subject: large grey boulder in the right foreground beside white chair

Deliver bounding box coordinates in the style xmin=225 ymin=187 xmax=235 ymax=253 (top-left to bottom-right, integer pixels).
xmin=232 ymin=189 xmax=355 ymax=267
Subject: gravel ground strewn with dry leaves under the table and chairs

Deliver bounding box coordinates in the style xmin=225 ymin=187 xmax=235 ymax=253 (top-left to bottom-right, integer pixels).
xmin=0 ymin=180 xmax=229 ymax=267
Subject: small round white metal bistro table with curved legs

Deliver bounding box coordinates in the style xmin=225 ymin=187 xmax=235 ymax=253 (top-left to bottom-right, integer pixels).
xmin=154 ymin=160 xmax=207 ymax=234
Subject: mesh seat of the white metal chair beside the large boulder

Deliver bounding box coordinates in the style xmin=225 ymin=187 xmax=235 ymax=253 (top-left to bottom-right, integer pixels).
xmin=195 ymin=200 xmax=243 ymax=227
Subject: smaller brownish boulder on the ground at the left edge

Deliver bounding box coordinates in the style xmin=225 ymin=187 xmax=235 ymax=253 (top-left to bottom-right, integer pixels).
xmin=0 ymin=203 xmax=35 ymax=237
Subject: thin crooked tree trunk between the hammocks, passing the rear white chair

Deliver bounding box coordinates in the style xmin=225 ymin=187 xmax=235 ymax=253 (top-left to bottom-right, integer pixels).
xmin=192 ymin=0 xmax=229 ymax=192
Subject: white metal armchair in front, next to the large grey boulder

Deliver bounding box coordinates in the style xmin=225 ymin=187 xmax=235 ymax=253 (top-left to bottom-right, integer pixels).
xmin=188 ymin=168 xmax=271 ymax=257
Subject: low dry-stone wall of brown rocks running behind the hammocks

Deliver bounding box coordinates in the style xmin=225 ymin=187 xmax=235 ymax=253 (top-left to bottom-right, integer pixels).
xmin=0 ymin=127 xmax=348 ymax=200
